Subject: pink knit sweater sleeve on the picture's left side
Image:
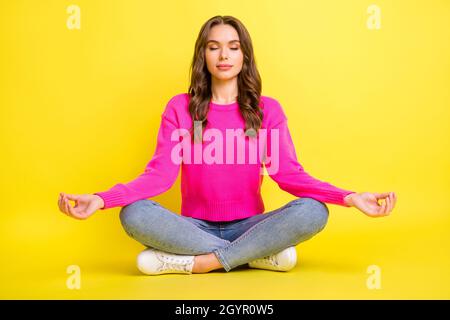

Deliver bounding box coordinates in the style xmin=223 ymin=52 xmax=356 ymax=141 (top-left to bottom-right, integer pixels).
xmin=94 ymin=105 xmax=180 ymax=210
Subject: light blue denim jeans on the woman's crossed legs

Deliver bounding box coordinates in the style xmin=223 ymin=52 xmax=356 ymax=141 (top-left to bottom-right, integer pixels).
xmin=120 ymin=198 xmax=329 ymax=272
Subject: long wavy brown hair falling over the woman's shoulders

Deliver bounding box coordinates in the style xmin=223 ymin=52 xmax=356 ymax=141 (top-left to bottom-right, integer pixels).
xmin=188 ymin=16 xmax=263 ymax=142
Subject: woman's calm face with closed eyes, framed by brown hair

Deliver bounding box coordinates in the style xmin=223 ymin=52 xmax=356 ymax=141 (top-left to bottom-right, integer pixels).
xmin=205 ymin=24 xmax=244 ymax=80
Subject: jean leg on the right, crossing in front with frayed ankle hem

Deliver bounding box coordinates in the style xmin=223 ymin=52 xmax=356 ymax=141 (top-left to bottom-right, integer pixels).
xmin=213 ymin=198 xmax=329 ymax=272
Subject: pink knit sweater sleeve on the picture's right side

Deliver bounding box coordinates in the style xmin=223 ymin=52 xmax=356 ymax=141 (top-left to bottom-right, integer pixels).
xmin=266 ymin=112 xmax=355 ymax=207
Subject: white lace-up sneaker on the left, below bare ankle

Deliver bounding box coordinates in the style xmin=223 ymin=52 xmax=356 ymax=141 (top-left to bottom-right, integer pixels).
xmin=137 ymin=248 xmax=194 ymax=275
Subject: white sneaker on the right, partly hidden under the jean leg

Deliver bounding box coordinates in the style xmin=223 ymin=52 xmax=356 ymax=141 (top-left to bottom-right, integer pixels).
xmin=248 ymin=247 xmax=297 ymax=271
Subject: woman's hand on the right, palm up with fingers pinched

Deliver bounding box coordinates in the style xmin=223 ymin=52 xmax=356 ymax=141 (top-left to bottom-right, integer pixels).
xmin=344 ymin=192 xmax=397 ymax=218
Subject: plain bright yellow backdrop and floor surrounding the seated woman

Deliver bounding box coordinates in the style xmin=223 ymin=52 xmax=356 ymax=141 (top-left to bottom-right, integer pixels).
xmin=0 ymin=0 xmax=450 ymax=299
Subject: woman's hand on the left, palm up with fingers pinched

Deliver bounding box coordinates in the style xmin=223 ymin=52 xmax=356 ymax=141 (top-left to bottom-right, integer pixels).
xmin=58 ymin=192 xmax=104 ymax=220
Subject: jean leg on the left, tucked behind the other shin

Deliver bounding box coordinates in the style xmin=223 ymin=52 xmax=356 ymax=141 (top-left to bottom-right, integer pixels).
xmin=120 ymin=200 xmax=230 ymax=255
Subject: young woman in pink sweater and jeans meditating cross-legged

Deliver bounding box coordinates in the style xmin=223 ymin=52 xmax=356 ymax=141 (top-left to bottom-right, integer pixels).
xmin=58 ymin=16 xmax=396 ymax=275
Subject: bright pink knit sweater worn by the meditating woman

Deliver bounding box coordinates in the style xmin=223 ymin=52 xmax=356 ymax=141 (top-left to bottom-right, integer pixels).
xmin=94 ymin=93 xmax=354 ymax=221
